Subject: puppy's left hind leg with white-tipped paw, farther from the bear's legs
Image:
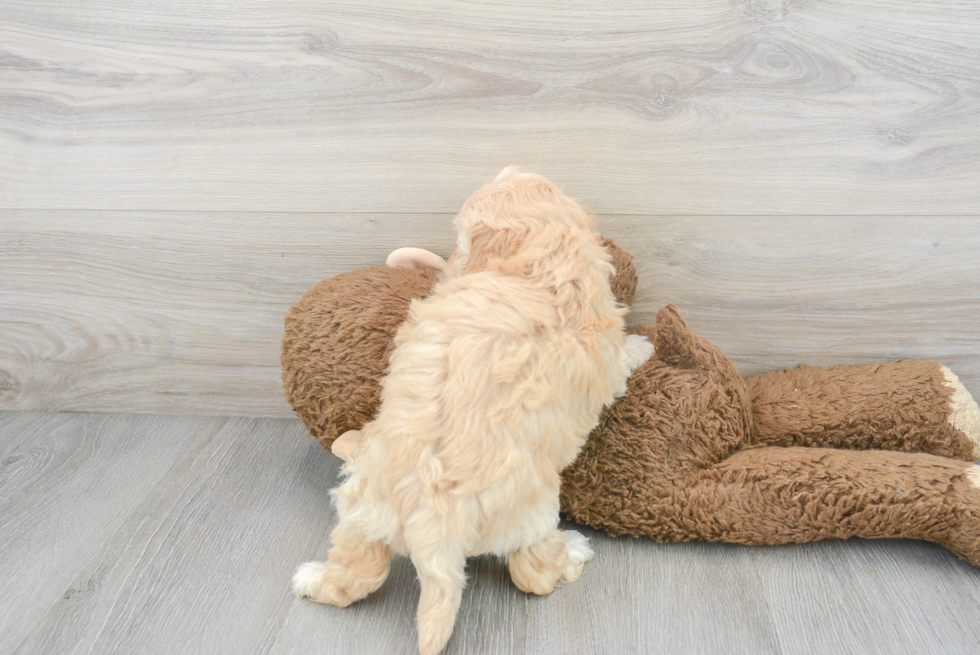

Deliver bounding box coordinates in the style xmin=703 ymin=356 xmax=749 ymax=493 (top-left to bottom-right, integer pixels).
xmin=293 ymin=520 xmax=391 ymax=607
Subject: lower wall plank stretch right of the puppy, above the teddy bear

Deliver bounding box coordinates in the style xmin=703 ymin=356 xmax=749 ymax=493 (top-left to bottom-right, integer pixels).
xmin=624 ymin=216 xmax=980 ymax=390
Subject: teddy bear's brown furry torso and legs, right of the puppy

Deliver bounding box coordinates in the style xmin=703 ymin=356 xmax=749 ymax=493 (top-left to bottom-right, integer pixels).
xmin=561 ymin=306 xmax=980 ymax=564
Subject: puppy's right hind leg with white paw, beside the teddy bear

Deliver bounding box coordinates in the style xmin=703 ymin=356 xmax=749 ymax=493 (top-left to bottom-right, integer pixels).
xmin=507 ymin=530 xmax=592 ymax=596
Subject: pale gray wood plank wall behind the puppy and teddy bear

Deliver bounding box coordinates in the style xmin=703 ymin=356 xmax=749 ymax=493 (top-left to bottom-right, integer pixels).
xmin=0 ymin=0 xmax=980 ymax=416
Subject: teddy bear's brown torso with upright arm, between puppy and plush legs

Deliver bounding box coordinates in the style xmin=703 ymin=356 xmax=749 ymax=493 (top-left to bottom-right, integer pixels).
xmin=561 ymin=305 xmax=752 ymax=538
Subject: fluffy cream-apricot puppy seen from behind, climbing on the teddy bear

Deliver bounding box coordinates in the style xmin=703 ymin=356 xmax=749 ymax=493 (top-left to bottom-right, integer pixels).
xmin=293 ymin=168 xmax=636 ymax=655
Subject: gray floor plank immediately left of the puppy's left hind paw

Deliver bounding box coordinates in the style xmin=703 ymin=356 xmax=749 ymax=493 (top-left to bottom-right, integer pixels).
xmin=10 ymin=419 xmax=336 ymax=654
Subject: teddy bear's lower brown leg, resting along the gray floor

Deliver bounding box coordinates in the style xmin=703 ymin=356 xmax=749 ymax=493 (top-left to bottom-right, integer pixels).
xmin=676 ymin=447 xmax=980 ymax=565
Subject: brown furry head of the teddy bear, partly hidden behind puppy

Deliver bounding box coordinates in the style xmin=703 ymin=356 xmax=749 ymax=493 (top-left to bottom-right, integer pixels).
xmin=281 ymin=239 xmax=637 ymax=450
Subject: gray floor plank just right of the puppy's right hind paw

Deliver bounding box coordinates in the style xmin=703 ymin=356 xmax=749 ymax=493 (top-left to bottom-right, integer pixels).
xmin=526 ymin=528 xmax=782 ymax=655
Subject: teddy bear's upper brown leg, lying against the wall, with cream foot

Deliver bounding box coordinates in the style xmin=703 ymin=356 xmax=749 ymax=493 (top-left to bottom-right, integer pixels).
xmin=745 ymin=360 xmax=980 ymax=461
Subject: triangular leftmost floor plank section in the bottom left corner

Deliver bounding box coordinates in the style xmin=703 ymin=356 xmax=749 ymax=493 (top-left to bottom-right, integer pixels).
xmin=0 ymin=413 xmax=213 ymax=653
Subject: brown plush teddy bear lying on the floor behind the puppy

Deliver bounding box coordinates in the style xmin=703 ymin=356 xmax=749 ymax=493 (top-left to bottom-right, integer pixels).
xmin=282 ymin=241 xmax=980 ymax=565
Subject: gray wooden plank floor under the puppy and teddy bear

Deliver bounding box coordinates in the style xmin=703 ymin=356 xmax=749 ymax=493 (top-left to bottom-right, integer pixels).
xmin=0 ymin=412 xmax=980 ymax=655
